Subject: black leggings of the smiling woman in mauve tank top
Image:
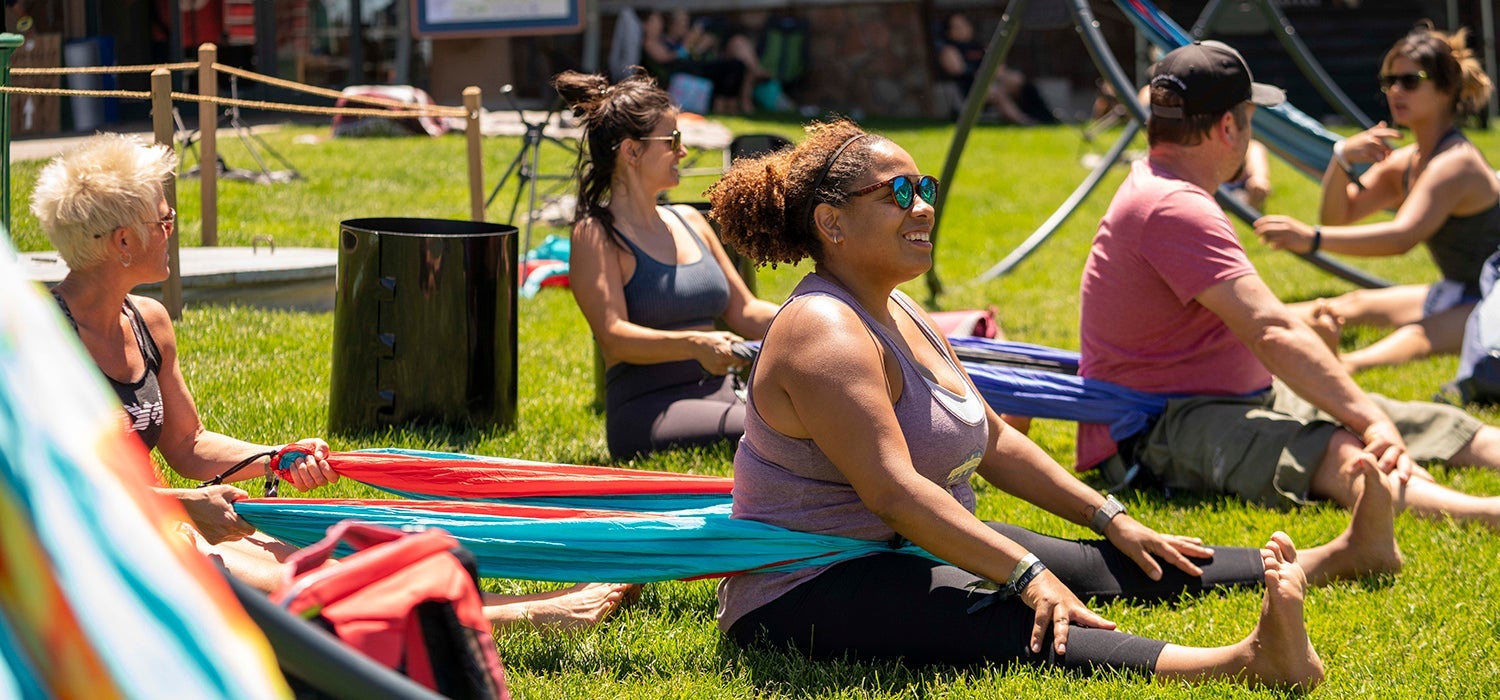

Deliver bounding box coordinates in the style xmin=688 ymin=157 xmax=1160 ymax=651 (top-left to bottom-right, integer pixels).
xmin=729 ymin=523 xmax=1265 ymax=673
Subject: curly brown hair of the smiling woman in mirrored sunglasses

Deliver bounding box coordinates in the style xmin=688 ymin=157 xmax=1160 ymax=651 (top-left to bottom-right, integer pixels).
xmin=707 ymin=118 xmax=888 ymax=267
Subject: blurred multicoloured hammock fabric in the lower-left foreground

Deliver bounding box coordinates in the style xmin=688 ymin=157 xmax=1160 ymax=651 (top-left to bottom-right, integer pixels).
xmin=0 ymin=236 xmax=290 ymax=699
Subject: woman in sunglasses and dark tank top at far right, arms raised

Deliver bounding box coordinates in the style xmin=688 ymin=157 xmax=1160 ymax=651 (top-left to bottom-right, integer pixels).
xmin=1256 ymin=22 xmax=1500 ymax=372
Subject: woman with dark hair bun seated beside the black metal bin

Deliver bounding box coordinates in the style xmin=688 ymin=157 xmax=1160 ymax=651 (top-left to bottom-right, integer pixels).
xmin=552 ymin=69 xmax=776 ymax=459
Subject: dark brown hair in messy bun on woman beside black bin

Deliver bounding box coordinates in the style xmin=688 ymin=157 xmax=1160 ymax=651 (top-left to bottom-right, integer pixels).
xmin=552 ymin=66 xmax=677 ymax=238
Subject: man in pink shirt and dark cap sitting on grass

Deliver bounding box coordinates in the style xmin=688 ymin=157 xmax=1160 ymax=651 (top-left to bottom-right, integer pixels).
xmin=1079 ymin=42 xmax=1500 ymax=526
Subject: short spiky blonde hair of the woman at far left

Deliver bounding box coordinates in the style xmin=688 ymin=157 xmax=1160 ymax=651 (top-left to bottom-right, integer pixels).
xmin=32 ymin=133 xmax=177 ymax=270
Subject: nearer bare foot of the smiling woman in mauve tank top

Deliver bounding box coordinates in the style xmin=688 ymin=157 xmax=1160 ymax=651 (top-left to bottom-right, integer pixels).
xmin=1242 ymin=532 xmax=1323 ymax=691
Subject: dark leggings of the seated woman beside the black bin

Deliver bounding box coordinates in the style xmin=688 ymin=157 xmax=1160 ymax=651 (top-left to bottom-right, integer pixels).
xmin=605 ymin=360 xmax=746 ymax=459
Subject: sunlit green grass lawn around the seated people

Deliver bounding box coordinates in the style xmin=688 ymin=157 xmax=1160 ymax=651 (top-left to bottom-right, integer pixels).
xmin=14 ymin=120 xmax=1500 ymax=699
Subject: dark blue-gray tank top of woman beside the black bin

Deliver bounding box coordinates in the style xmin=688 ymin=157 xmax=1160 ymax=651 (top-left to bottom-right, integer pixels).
xmin=615 ymin=207 xmax=729 ymax=330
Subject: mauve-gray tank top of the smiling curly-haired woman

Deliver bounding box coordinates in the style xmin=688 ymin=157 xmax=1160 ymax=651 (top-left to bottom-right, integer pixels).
xmin=719 ymin=274 xmax=989 ymax=631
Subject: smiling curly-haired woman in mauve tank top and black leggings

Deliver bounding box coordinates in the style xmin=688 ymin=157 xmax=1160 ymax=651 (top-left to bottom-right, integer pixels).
xmin=710 ymin=121 xmax=1400 ymax=687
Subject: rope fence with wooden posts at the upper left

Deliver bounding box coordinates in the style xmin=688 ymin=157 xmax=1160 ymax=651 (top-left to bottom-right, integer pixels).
xmin=0 ymin=41 xmax=485 ymax=318
